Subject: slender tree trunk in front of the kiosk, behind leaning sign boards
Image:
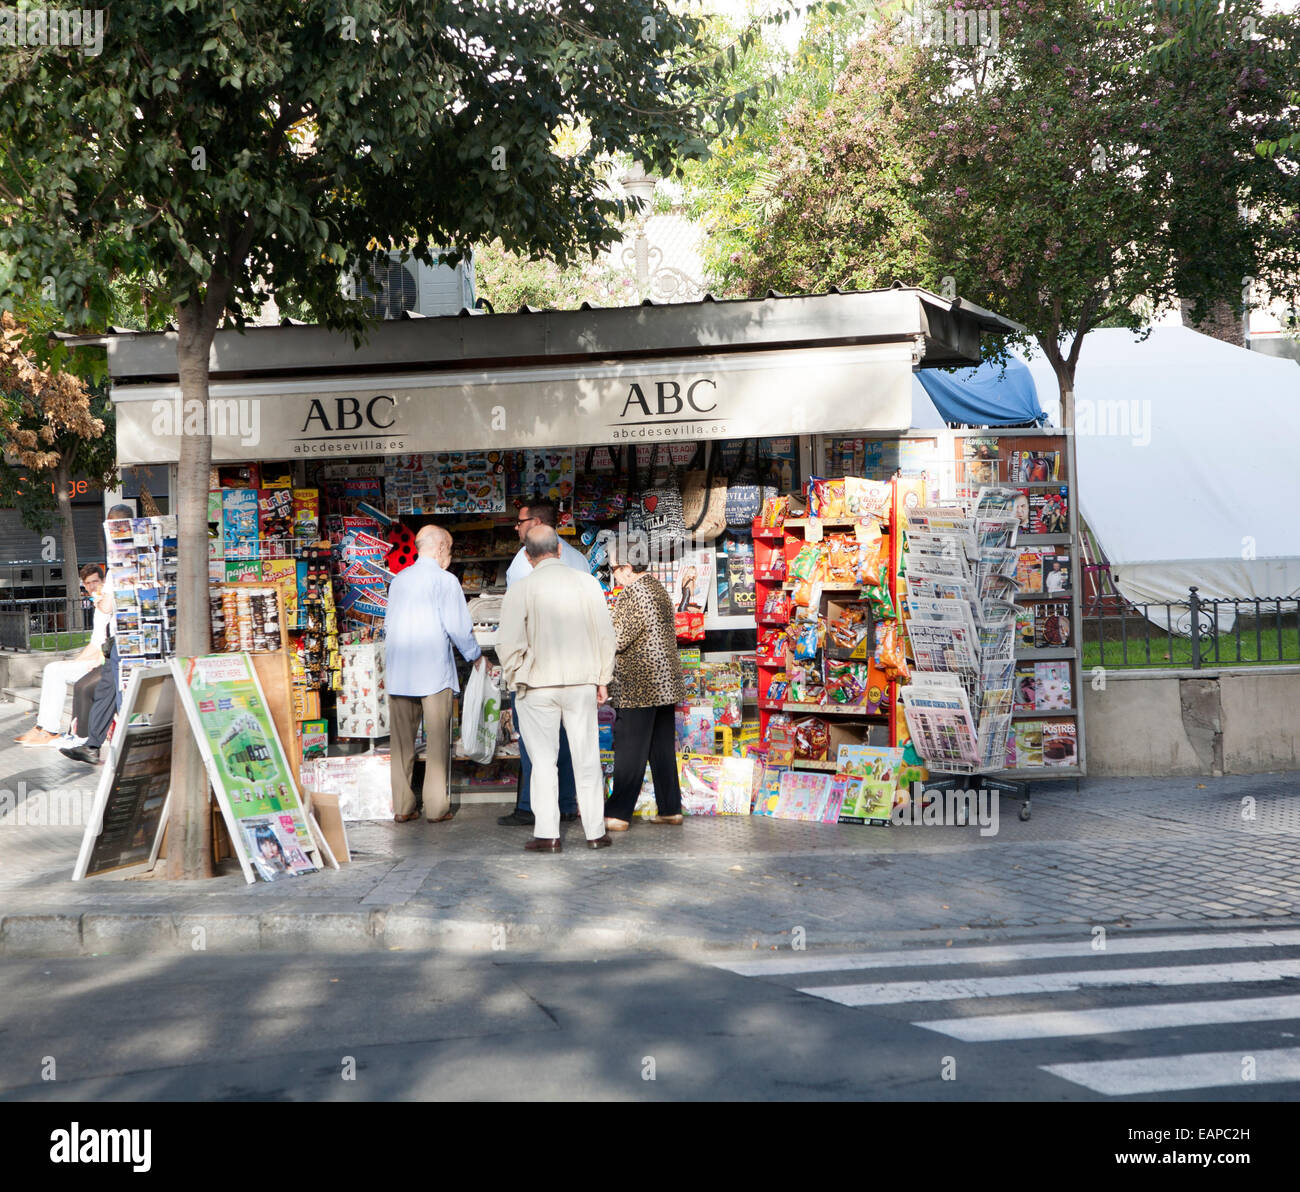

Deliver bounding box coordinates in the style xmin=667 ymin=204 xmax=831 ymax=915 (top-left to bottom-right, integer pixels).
xmin=166 ymin=303 xmax=216 ymax=877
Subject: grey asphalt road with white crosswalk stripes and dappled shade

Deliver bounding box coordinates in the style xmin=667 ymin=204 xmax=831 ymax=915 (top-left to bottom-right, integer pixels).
xmin=0 ymin=927 xmax=1300 ymax=1107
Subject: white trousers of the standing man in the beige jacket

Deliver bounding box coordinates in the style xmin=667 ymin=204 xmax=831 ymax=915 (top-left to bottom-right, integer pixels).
xmin=515 ymin=684 xmax=605 ymax=840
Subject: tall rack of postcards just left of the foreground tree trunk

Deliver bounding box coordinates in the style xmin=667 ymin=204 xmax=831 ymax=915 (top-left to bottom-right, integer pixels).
xmin=104 ymin=517 xmax=179 ymax=692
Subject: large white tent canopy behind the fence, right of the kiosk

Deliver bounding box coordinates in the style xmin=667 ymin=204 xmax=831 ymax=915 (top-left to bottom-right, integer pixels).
xmin=913 ymin=326 xmax=1300 ymax=603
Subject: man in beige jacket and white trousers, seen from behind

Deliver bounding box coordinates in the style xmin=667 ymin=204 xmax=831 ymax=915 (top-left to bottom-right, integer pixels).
xmin=497 ymin=525 xmax=615 ymax=853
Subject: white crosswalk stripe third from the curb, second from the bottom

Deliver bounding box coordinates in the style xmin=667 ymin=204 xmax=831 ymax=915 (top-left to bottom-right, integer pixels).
xmin=913 ymin=996 xmax=1300 ymax=1043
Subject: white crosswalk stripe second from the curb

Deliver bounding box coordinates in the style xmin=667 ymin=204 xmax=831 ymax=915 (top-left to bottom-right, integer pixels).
xmin=800 ymin=961 xmax=1300 ymax=1006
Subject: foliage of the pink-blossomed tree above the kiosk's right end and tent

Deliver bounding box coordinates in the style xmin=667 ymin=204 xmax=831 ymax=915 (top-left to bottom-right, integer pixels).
xmin=722 ymin=0 xmax=1300 ymax=409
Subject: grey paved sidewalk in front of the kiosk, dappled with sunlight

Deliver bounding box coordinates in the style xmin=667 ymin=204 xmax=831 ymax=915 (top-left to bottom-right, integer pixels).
xmin=0 ymin=705 xmax=1300 ymax=955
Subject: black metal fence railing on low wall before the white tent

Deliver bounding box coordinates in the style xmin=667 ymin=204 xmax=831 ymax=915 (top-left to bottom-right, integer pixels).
xmin=1083 ymin=588 xmax=1300 ymax=671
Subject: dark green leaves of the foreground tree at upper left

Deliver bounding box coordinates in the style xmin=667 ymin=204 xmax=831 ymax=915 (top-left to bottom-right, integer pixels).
xmin=0 ymin=0 xmax=722 ymax=337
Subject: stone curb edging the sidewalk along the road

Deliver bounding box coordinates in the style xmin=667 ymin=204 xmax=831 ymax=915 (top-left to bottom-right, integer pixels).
xmin=0 ymin=910 xmax=1300 ymax=959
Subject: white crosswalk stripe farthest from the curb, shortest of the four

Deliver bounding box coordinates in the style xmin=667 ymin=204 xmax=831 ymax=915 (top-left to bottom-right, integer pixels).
xmin=1039 ymin=1048 xmax=1300 ymax=1097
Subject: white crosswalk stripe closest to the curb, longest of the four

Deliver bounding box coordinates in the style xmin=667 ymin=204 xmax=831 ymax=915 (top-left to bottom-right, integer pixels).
xmin=714 ymin=931 xmax=1300 ymax=976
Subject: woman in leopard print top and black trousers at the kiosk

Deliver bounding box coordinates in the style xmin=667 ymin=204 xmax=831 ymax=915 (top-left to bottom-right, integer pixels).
xmin=605 ymin=563 xmax=686 ymax=832
